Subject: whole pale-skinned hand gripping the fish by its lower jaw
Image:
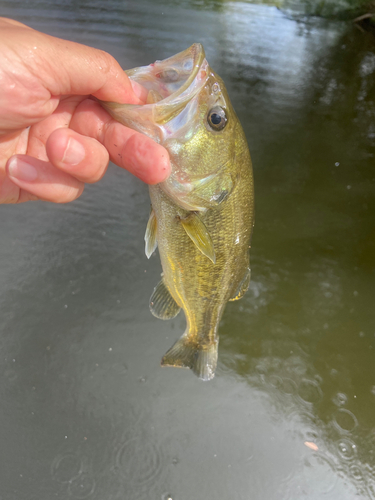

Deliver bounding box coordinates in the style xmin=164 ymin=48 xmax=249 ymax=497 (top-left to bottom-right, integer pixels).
xmin=0 ymin=18 xmax=170 ymax=203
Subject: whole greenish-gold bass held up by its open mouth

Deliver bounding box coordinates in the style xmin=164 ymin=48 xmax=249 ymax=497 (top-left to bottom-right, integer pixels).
xmin=101 ymin=43 xmax=254 ymax=381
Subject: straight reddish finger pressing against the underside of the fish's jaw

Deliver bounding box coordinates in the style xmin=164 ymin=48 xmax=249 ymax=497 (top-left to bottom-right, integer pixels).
xmin=70 ymin=99 xmax=171 ymax=184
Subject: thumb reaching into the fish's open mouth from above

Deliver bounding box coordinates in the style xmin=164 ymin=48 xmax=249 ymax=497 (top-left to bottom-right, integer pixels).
xmin=0 ymin=18 xmax=143 ymax=104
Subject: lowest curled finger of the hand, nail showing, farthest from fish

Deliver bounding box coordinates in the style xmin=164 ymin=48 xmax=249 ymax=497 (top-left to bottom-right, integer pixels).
xmin=6 ymin=155 xmax=84 ymax=203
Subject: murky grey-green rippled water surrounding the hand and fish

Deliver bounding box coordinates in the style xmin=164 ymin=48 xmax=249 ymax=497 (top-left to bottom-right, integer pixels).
xmin=0 ymin=0 xmax=375 ymax=500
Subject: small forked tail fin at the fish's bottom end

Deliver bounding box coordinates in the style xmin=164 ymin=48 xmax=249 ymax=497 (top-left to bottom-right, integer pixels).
xmin=161 ymin=335 xmax=218 ymax=380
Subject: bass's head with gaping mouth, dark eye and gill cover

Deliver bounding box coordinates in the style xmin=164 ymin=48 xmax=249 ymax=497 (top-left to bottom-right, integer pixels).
xmin=101 ymin=43 xmax=239 ymax=211
